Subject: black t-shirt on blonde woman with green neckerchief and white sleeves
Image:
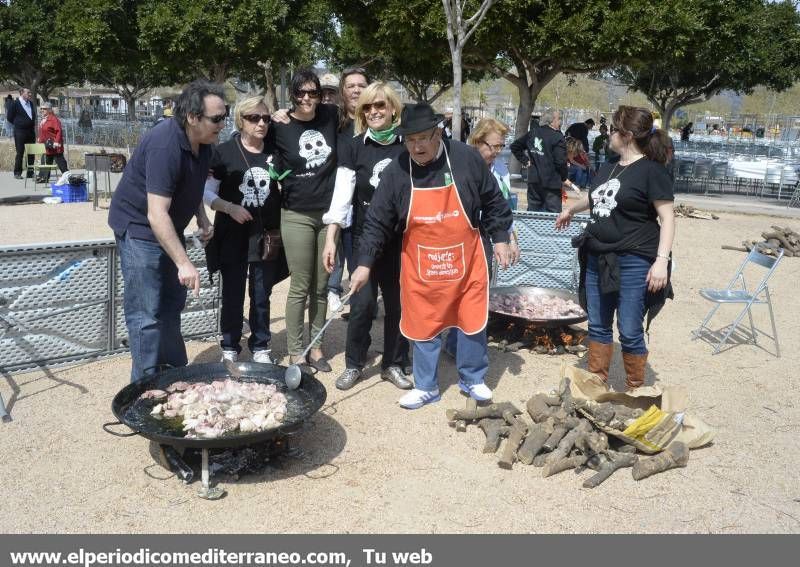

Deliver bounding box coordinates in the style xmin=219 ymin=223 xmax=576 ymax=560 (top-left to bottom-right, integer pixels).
xmin=339 ymin=134 xmax=404 ymax=237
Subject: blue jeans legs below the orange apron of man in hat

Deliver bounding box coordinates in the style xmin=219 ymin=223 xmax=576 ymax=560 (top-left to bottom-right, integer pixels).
xmin=412 ymin=329 xmax=489 ymax=392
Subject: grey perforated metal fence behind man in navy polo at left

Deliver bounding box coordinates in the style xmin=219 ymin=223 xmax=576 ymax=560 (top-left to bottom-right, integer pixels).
xmin=0 ymin=240 xmax=220 ymax=372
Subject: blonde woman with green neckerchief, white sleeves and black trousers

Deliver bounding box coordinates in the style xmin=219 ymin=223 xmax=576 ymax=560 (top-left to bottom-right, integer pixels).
xmin=322 ymin=82 xmax=412 ymax=390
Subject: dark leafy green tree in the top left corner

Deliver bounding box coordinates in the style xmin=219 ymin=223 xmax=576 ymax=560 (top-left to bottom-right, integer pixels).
xmin=0 ymin=0 xmax=75 ymax=99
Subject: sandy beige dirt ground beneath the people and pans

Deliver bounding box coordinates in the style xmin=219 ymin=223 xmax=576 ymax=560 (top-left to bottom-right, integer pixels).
xmin=0 ymin=199 xmax=800 ymax=533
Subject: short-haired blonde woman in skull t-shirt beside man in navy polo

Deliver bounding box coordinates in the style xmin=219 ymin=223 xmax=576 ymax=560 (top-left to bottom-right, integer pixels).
xmin=203 ymin=97 xmax=288 ymax=364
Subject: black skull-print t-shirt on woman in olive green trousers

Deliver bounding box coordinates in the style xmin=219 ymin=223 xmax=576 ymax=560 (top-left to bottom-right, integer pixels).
xmin=267 ymin=104 xmax=339 ymax=211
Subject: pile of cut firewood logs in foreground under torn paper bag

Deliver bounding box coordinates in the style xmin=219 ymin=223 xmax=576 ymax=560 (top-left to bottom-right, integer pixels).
xmin=447 ymin=378 xmax=689 ymax=488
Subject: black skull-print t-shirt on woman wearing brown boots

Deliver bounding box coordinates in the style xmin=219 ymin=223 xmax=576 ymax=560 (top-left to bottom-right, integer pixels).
xmin=587 ymin=158 xmax=675 ymax=257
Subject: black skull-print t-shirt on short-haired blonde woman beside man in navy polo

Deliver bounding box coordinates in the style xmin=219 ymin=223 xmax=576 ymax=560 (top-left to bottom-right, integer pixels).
xmin=211 ymin=135 xmax=281 ymax=263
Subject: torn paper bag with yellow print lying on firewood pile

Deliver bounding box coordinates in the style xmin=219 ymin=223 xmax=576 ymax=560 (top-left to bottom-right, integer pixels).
xmin=561 ymin=361 xmax=714 ymax=454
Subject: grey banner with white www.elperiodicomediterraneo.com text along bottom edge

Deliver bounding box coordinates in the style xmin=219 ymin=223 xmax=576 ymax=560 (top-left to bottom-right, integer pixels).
xmin=0 ymin=535 xmax=800 ymax=567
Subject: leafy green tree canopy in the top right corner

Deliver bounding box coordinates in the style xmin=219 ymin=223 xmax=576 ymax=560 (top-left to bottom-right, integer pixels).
xmin=613 ymin=0 xmax=800 ymax=128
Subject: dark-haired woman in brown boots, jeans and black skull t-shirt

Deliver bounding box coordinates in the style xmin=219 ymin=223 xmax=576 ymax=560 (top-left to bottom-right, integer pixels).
xmin=556 ymin=106 xmax=675 ymax=390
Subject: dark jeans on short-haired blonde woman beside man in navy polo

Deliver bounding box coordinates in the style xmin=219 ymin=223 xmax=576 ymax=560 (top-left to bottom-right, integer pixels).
xmin=220 ymin=260 xmax=280 ymax=353
